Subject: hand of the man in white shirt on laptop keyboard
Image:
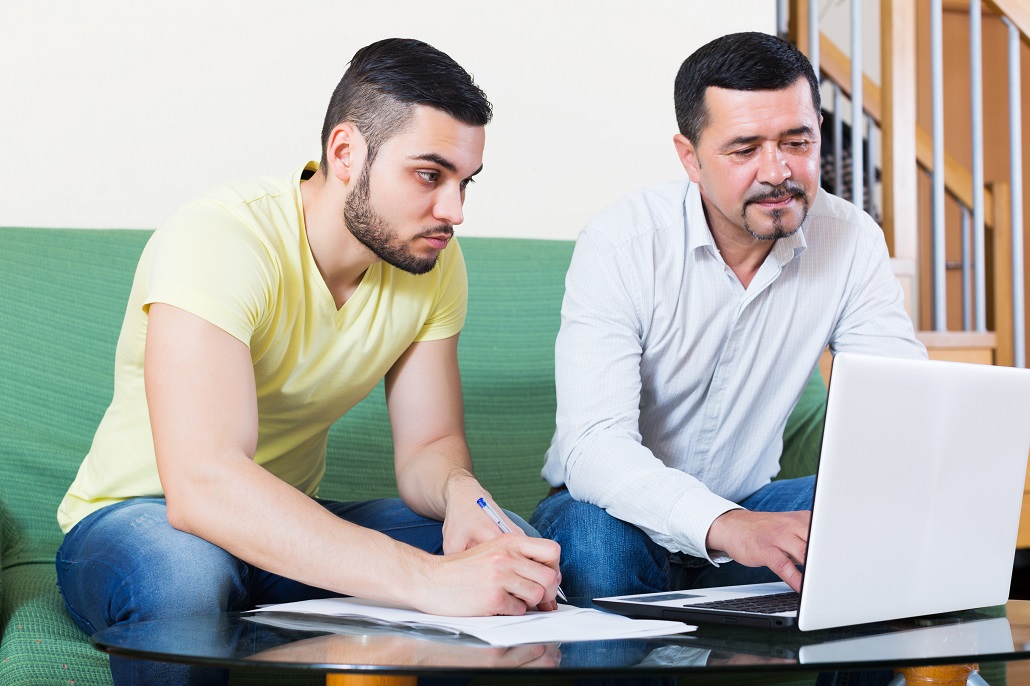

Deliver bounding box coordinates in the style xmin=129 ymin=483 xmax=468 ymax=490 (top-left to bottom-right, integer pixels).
xmin=706 ymin=510 xmax=812 ymax=591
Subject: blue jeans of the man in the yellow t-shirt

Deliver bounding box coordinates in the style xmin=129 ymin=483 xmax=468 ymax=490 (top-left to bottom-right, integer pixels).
xmin=57 ymin=498 xmax=539 ymax=685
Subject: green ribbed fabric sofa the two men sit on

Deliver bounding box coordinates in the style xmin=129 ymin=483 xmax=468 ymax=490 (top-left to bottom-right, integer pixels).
xmin=0 ymin=228 xmax=826 ymax=686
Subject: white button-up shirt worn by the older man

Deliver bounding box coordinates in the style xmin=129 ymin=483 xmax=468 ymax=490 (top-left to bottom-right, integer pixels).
xmin=543 ymin=181 xmax=926 ymax=561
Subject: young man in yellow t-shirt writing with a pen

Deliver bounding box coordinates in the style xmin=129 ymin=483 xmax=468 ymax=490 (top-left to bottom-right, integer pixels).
xmin=57 ymin=39 xmax=558 ymax=683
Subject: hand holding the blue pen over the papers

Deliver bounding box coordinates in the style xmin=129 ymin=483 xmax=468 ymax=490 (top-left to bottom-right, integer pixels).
xmin=409 ymin=527 xmax=560 ymax=616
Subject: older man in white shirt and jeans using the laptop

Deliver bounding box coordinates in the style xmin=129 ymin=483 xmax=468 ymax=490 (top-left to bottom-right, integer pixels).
xmin=530 ymin=33 xmax=926 ymax=597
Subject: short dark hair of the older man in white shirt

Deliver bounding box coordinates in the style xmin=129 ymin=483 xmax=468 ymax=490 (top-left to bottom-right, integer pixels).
xmin=674 ymin=31 xmax=821 ymax=144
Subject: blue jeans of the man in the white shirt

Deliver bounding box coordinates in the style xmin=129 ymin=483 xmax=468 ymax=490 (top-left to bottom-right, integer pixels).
xmin=529 ymin=477 xmax=815 ymax=598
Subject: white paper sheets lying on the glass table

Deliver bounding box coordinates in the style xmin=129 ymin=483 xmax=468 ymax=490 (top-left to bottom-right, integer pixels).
xmin=256 ymin=597 xmax=696 ymax=646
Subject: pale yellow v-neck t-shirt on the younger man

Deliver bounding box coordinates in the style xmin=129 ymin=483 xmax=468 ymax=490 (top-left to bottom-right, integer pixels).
xmin=58 ymin=163 xmax=468 ymax=533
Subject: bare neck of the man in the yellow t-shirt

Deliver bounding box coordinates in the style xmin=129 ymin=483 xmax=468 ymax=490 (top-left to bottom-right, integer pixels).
xmin=301 ymin=172 xmax=379 ymax=308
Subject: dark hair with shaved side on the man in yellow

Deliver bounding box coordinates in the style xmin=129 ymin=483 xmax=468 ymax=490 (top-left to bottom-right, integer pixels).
xmin=320 ymin=38 xmax=493 ymax=173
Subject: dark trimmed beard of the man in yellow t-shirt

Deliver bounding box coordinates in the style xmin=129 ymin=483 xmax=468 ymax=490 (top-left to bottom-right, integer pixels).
xmin=343 ymin=163 xmax=454 ymax=274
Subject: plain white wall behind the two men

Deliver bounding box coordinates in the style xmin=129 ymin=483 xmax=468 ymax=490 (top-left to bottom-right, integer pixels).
xmin=0 ymin=0 xmax=776 ymax=238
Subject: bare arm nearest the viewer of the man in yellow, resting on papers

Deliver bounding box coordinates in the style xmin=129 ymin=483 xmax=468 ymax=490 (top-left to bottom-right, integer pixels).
xmin=144 ymin=304 xmax=548 ymax=614
